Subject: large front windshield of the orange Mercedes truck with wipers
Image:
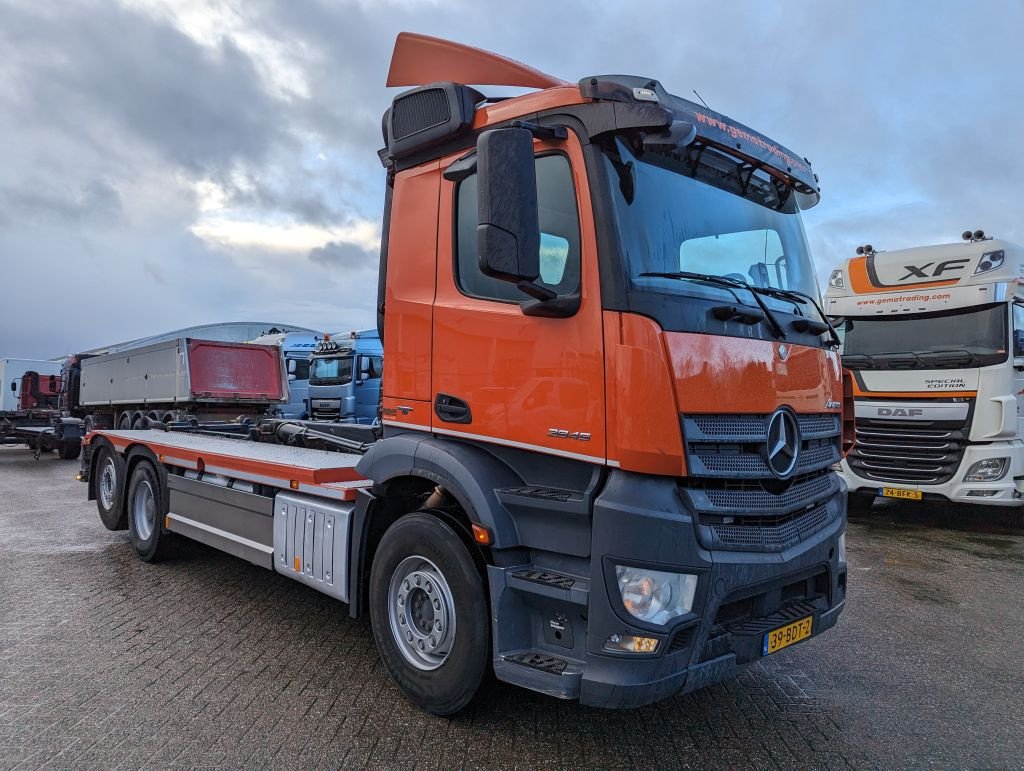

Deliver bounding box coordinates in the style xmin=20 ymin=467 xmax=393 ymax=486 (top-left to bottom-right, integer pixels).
xmin=604 ymin=139 xmax=820 ymax=329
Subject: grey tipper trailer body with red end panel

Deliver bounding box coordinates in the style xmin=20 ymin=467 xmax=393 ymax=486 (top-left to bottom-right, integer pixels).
xmin=61 ymin=338 xmax=288 ymax=430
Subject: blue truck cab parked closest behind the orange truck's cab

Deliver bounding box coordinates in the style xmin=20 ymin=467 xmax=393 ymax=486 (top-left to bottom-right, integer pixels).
xmin=307 ymin=330 xmax=384 ymax=424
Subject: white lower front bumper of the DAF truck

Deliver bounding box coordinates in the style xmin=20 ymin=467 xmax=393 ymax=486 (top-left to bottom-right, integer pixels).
xmin=840 ymin=439 xmax=1024 ymax=506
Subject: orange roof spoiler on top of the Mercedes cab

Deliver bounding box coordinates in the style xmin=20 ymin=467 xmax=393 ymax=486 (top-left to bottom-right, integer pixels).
xmin=387 ymin=32 xmax=568 ymax=88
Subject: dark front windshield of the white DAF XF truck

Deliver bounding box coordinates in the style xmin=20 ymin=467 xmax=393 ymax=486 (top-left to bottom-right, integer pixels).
xmin=837 ymin=303 xmax=1010 ymax=370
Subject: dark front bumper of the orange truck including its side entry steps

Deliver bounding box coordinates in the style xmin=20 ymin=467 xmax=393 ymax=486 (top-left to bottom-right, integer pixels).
xmin=488 ymin=471 xmax=847 ymax=709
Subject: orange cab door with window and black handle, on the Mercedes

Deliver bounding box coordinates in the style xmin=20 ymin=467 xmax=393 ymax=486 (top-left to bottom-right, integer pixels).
xmin=431 ymin=132 xmax=605 ymax=463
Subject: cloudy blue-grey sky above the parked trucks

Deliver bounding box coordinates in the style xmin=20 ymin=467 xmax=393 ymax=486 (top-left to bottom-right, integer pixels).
xmin=0 ymin=0 xmax=1024 ymax=357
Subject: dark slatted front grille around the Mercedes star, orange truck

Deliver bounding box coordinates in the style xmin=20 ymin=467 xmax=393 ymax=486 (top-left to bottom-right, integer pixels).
xmin=679 ymin=414 xmax=842 ymax=552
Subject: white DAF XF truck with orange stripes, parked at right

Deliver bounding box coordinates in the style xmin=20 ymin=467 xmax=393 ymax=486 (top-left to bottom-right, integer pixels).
xmin=825 ymin=230 xmax=1024 ymax=506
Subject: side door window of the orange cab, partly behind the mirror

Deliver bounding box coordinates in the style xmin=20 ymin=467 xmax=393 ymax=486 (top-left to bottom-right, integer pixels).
xmin=455 ymin=155 xmax=580 ymax=303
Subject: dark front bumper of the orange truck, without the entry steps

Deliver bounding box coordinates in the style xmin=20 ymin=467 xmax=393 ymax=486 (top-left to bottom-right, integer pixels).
xmin=580 ymin=472 xmax=847 ymax=708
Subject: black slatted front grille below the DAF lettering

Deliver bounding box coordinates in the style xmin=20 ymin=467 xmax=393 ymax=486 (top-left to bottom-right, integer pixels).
xmin=847 ymin=418 xmax=968 ymax=484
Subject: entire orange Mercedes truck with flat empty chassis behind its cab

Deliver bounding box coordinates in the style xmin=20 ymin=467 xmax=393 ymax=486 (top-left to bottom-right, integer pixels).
xmin=82 ymin=34 xmax=852 ymax=714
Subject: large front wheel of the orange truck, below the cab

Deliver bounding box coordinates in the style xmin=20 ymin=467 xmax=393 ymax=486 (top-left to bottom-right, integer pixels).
xmin=370 ymin=512 xmax=490 ymax=715
